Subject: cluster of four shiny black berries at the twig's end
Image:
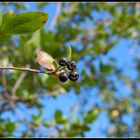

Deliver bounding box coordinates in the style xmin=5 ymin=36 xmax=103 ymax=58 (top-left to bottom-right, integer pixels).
xmin=59 ymin=57 xmax=79 ymax=82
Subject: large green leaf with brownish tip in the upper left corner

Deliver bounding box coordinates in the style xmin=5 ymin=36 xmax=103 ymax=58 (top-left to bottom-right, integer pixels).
xmin=2 ymin=12 xmax=48 ymax=34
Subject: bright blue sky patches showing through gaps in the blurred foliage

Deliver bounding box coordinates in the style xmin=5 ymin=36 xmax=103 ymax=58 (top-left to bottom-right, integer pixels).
xmin=0 ymin=2 xmax=137 ymax=137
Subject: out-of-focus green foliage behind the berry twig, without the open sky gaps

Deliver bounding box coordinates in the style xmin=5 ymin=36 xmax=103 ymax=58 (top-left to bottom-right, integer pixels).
xmin=0 ymin=2 xmax=140 ymax=137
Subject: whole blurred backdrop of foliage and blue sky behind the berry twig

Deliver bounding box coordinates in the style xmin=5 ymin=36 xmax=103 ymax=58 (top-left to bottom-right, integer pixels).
xmin=0 ymin=2 xmax=140 ymax=137
